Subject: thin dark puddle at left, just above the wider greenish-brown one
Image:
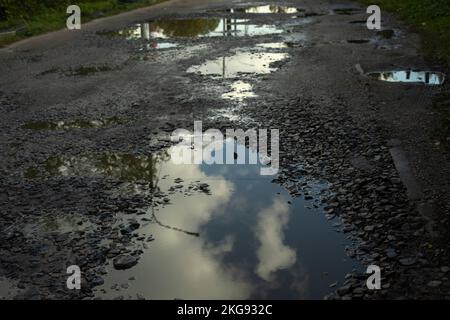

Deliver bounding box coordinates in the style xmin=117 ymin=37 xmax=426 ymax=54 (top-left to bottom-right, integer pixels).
xmin=21 ymin=117 xmax=125 ymax=130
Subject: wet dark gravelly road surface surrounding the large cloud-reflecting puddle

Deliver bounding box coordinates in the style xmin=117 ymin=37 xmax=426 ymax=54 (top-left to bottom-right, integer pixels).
xmin=0 ymin=0 xmax=450 ymax=299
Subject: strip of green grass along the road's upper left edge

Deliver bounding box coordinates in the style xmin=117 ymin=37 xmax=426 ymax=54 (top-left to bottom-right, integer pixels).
xmin=0 ymin=0 xmax=165 ymax=48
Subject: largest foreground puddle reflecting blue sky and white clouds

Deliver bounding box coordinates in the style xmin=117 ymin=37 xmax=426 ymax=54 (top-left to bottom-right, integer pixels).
xmin=91 ymin=140 xmax=360 ymax=299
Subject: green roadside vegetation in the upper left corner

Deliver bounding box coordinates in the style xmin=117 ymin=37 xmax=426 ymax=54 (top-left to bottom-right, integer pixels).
xmin=0 ymin=0 xmax=164 ymax=47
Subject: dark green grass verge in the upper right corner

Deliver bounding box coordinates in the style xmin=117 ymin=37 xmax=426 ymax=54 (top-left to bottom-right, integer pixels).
xmin=360 ymin=0 xmax=450 ymax=66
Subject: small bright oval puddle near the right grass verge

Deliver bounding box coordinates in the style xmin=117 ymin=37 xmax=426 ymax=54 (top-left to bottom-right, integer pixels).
xmin=367 ymin=71 xmax=445 ymax=86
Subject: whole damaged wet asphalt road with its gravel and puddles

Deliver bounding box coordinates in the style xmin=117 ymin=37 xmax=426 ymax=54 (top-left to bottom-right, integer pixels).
xmin=0 ymin=0 xmax=450 ymax=299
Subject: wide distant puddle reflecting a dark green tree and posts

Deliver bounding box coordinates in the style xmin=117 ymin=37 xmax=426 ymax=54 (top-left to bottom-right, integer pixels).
xmin=107 ymin=18 xmax=284 ymax=40
